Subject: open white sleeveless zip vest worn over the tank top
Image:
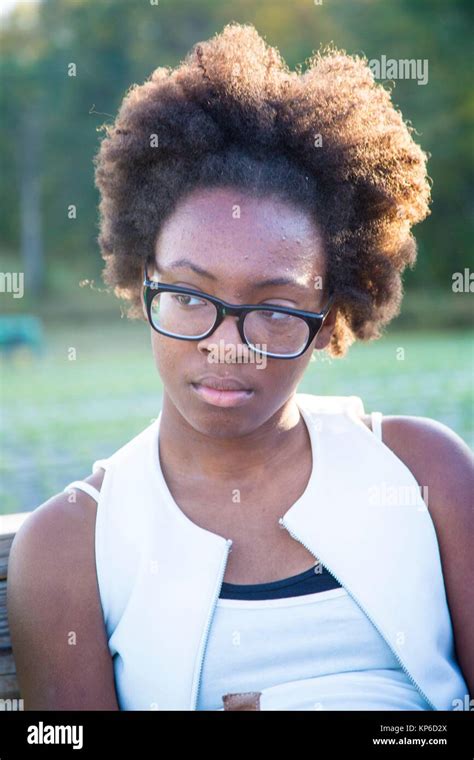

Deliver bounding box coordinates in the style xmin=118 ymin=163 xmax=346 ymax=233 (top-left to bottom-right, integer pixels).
xmin=65 ymin=393 xmax=468 ymax=710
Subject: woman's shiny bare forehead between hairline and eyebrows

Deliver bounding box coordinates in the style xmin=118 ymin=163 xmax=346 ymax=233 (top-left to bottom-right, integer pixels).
xmin=155 ymin=188 xmax=324 ymax=281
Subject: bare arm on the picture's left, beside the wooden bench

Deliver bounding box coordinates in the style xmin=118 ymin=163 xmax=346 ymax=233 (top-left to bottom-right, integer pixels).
xmin=7 ymin=470 xmax=119 ymax=710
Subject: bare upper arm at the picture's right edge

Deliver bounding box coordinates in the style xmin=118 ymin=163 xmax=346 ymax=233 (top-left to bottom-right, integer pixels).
xmin=383 ymin=417 xmax=474 ymax=697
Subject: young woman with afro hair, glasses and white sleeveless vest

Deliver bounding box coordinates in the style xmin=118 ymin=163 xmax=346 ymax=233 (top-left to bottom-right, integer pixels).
xmin=8 ymin=24 xmax=474 ymax=710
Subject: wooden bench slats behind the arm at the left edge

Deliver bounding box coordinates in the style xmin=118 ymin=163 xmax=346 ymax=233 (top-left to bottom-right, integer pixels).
xmin=0 ymin=512 xmax=31 ymax=700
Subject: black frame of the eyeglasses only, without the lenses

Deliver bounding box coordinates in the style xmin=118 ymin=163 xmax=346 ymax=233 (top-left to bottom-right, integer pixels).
xmin=143 ymin=264 xmax=335 ymax=359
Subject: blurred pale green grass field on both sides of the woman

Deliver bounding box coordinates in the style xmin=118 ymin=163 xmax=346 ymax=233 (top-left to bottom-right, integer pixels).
xmin=0 ymin=319 xmax=474 ymax=514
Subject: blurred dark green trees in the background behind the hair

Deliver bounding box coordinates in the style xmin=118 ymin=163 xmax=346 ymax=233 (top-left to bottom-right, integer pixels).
xmin=0 ymin=0 xmax=474 ymax=312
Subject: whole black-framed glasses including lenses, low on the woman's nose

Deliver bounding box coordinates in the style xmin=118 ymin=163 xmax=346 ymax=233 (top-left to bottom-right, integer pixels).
xmin=143 ymin=266 xmax=334 ymax=359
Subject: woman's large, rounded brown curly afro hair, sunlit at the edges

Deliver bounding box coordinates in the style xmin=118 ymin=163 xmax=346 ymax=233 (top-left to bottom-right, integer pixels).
xmin=94 ymin=23 xmax=430 ymax=357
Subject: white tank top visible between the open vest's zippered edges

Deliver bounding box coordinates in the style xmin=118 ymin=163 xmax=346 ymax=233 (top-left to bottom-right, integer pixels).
xmin=197 ymin=588 xmax=432 ymax=710
